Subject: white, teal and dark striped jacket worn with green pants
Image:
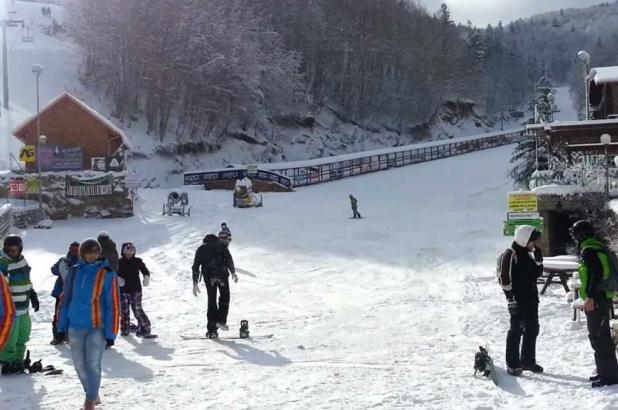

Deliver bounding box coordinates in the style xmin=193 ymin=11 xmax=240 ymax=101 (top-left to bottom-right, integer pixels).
xmin=0 ymin=251 xmax=32 ymax=316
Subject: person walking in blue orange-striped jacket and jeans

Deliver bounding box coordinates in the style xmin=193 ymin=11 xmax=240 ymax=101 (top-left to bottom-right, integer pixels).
xmin=58 ymin=239 xmax=120 ymax=410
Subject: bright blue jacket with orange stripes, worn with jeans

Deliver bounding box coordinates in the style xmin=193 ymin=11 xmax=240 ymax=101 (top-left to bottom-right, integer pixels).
xmin=57 ymin=259 xmax=120 ymax=340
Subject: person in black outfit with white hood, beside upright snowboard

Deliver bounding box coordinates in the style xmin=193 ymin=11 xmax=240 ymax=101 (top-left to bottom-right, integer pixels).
xmin=499 ymin=225 xmax=543 ymax=376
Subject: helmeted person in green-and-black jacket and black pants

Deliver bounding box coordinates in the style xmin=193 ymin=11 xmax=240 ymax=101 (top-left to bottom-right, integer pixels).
xmin=569 ymin=220 xmax=618 ymax=388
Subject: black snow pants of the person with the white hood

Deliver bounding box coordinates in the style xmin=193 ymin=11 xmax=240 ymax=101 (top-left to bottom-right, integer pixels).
xmin=506 ymin=302 xmax=539 ymax=368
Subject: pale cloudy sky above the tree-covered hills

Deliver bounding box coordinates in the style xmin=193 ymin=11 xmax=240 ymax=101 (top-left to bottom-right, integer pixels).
xmin=416 ymin=0 xmax=611 ymax=27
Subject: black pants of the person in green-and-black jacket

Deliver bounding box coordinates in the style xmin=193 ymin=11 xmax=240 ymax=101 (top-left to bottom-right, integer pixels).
xmin=586 ymin=298 xmax=618 ymax=382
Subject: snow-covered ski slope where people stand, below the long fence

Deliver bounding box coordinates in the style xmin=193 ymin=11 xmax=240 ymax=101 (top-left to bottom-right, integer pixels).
xmin=0 ymin=147 xmax=618 ymax=410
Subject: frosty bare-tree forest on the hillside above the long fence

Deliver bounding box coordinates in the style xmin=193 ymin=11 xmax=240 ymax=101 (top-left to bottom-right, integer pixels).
xmin=62 ymin=0 xmax=541 ymax=151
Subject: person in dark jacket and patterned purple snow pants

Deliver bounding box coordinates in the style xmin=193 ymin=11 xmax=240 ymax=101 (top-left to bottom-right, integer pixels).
xmin=118 ymin=242 xmax=150 ymax=337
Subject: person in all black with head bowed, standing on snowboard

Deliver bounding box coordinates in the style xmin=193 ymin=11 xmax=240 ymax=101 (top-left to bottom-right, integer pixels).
xmin=192 ymin=234 xmax=238 ymax=338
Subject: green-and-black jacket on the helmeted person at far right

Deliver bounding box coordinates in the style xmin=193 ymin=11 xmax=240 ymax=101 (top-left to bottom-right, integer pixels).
xmin=578 ymin=238 xmax=616 ymax=300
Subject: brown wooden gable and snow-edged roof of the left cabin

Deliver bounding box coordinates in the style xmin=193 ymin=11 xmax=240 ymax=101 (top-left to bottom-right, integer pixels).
xmin=13 ymin=93 xmax=129 ymax=172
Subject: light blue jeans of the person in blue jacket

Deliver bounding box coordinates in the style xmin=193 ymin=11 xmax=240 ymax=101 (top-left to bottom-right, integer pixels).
xmin=69 ymin=328 xmax=106 ymax=400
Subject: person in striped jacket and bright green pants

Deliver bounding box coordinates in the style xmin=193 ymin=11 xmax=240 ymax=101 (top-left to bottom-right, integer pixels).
xmin=0 ymin=235 xmax=39 ymax=374
